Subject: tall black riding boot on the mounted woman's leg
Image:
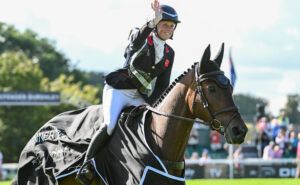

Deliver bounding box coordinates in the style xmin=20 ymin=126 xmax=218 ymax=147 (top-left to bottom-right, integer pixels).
xmin=76 ymin=125 xmax=109 ymax=185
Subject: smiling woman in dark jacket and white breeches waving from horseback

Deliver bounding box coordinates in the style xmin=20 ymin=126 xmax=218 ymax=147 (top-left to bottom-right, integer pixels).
xmin=77 ymin=0 xmax=180 ymax=183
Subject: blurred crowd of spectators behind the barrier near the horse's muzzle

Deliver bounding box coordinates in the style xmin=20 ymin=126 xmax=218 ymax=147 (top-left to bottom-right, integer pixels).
xmin=187 ymin=107 xmax=300 ymax=160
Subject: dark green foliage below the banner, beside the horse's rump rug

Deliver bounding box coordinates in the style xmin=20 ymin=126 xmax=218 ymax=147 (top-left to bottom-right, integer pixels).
xmin=0 ymin=106 xmax=53 ymax=162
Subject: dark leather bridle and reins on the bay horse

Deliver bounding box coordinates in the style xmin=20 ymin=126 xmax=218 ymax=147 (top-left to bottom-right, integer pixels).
xmin=146 ymin=63 xmax=240 ymax=135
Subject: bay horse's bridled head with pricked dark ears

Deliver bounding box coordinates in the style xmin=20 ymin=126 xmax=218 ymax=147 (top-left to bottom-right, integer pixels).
xmin=190 ymin=44 xmax=248 ymax=144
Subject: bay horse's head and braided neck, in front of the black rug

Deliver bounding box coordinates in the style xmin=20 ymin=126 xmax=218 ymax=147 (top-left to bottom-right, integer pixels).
xmin=60 ymin=44 xmax=248 ymax=184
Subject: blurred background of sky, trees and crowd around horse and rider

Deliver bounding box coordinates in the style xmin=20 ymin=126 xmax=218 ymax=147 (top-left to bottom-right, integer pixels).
xmin=0 ymin=0 xmax=300 ymax=179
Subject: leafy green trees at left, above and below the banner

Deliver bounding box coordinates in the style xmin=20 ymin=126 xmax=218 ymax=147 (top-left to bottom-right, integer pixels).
xmin=0 ymin=22 xmax=103 ymax=162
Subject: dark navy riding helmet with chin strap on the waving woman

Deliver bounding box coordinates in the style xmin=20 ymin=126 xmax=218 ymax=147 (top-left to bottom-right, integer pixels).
xmin=155 ymin=4 xmax=181 ymax=39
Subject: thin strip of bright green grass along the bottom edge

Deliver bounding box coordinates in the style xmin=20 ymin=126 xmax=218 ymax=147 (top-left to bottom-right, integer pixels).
xmin=0 ymin=178 xmax=300 ymax=185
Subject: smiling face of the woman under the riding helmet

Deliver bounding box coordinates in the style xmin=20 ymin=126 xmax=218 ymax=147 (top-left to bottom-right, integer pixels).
xmin=157 ymin=21 xmax=176 ymax=40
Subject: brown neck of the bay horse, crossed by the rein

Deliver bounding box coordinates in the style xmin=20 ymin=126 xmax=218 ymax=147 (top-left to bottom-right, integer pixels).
xmin=152 ymin=71 xmax=194 ymax=173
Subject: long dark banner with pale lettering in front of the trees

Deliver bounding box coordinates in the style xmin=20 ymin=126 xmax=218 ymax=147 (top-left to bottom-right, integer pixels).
xmin=0 ymin=92 xmax=60 ymax=106
